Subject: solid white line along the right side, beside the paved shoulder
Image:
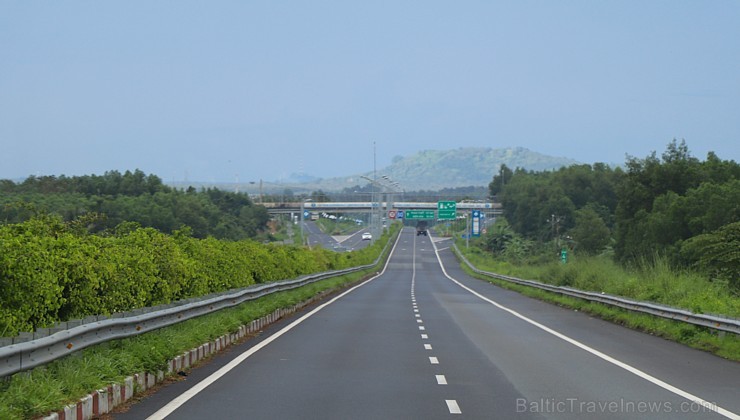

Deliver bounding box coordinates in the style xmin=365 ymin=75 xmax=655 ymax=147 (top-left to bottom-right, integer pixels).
xmin=432 ymin=235 xmax=740 ymax=420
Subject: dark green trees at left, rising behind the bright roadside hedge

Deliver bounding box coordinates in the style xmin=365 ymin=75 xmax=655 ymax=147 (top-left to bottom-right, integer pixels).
xmin=0 ymin=170 xmax=269 ymax=240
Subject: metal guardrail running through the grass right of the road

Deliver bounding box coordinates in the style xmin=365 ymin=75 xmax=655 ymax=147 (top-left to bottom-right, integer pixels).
xmin=453 ymin=244 xmax=740 ymax=334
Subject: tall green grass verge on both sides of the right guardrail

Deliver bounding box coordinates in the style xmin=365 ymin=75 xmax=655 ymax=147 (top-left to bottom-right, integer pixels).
xmin=460 ymin=247 xmax=740 ymax=361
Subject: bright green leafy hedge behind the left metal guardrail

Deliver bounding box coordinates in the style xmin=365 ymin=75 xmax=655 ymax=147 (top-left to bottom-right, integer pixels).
xmin=0 ymin=215 xmax=379 ymax=336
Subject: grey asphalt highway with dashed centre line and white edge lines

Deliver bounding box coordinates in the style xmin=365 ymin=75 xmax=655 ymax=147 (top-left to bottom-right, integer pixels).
xmin=114 ymin=228 xmax=740 ymax=419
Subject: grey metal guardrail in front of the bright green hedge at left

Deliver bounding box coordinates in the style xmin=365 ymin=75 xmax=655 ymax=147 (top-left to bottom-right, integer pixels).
xmin=0 ymin=233 xmax=392 ymax=377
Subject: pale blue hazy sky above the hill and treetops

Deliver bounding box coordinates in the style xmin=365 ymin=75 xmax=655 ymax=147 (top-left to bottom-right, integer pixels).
xmin=0 ymin=0 xmax=740 ymax=183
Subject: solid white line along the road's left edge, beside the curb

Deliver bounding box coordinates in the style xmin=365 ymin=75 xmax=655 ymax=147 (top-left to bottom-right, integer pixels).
xmin=147 ymin=233 xmax=401 ymax=420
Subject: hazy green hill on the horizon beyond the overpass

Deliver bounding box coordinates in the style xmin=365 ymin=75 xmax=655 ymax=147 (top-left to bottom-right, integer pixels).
xmin=300 ymin=147 xmax=578 ymax=191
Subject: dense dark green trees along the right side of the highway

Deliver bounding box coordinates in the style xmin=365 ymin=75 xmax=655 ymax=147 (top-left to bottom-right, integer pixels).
xmin=482 ymin=140 xmax=740 ymax=292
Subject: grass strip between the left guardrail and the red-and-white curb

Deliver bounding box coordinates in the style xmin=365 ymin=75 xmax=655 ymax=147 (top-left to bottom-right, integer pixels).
xmin=0 ymin=235 xmax=394 ymax=419
